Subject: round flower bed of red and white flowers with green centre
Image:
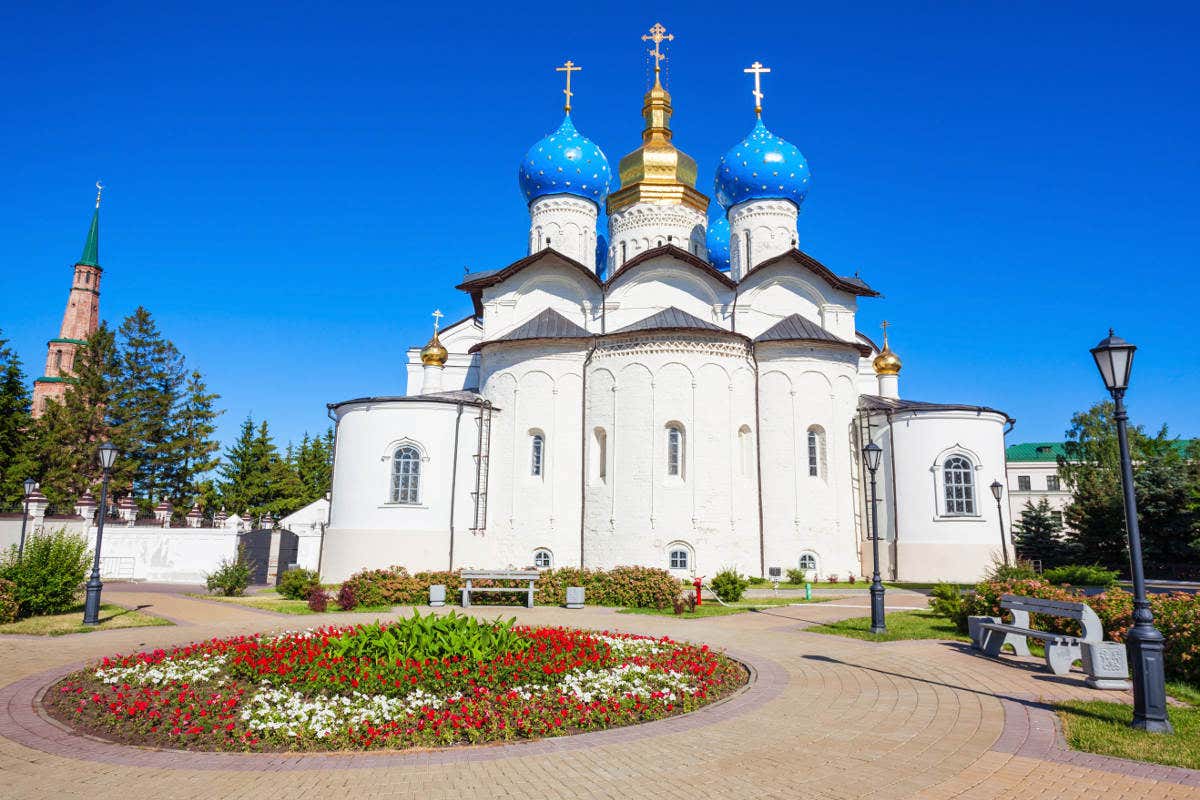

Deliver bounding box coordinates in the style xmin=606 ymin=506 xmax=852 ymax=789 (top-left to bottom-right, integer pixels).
xmin=44 ymin=615 xmax=746 ymax=751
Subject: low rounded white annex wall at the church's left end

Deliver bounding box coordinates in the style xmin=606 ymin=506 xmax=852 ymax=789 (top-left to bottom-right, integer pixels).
xmin=320 ymin=401 xmax=479 ymax=581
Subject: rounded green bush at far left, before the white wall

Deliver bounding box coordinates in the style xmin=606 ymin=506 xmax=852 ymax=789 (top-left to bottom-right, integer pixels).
xmin=0 ymin=529 xmax=91 ymax=619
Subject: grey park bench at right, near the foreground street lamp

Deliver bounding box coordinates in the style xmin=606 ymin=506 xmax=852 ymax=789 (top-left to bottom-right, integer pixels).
xmin=971 ymin=595 xmax=1104 ymax=675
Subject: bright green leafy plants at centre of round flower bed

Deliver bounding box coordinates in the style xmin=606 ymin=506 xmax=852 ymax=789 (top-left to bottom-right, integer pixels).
xmin=328 ymin=610 xmax=530 ymax=663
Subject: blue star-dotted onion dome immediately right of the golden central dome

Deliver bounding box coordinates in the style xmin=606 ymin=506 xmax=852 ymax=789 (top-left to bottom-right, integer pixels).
xmin=715 ymin=116 xmax=811 ymax=209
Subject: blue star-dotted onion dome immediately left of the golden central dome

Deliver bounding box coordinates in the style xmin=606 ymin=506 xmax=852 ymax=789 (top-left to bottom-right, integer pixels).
xmin=517 ymin=114 xmax=612 ymax=205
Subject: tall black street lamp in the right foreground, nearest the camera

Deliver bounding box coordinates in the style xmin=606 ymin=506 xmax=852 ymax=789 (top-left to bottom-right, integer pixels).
xmin=1092 ymin=327 xmax=1171 ymax=733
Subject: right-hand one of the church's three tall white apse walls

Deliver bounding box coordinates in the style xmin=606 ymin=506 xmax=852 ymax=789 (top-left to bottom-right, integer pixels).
xmin=758 ymin=343 xmax=860 ymax=577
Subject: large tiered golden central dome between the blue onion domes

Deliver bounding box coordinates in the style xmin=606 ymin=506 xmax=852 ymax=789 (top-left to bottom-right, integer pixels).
xmin=607 ymin=68 xmax=708 ymax=213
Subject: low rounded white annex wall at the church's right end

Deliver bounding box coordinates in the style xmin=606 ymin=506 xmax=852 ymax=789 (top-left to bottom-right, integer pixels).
xmin=862 ymin=410 xmax=1013 ymax=583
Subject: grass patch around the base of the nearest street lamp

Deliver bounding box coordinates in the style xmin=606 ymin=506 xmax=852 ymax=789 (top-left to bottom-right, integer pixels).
xmin=1057 ymin=684 xmax=1200 ymax=769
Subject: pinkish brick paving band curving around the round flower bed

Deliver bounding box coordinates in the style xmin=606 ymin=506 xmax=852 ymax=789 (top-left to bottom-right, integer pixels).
xmin=0 ymin=650 xmax=788 ymax=771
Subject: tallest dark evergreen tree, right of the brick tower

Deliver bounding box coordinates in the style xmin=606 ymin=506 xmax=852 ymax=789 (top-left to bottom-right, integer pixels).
xmin=113 ymin=306 xmax=185 ymax=510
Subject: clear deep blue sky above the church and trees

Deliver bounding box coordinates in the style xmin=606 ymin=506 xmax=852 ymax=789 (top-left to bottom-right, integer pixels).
xmin=0 ymin=2 xmax=1200 ymax=453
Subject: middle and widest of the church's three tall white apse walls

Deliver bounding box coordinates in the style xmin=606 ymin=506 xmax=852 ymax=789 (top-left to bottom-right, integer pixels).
xmin=584 ymin=333 xmax=758 ymax=576
